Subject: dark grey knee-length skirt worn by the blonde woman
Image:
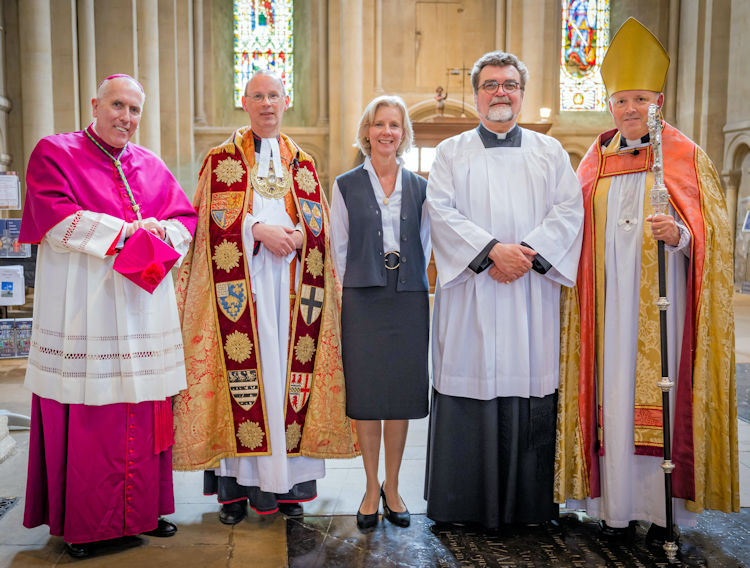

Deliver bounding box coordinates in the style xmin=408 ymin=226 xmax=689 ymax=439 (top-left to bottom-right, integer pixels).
xmin=341 ymin=270 xmax=430 ymax=420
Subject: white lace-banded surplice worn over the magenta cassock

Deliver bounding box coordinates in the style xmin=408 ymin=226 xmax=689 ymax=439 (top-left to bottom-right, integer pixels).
xmin=25 ymin=211 xmax=191 ymax=405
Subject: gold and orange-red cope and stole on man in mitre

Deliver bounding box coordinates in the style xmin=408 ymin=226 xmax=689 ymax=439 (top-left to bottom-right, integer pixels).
xmin=555 ymin=124 xmax=739 ymax=512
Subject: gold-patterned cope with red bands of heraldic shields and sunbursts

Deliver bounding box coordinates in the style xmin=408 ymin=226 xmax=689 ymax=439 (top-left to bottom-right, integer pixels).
xmin=173 ymin=127 xmax=358 ymax=470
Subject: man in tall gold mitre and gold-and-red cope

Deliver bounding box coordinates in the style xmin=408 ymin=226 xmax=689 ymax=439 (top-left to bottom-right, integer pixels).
xmin=555 ymin=18 xmax=740 ymax=546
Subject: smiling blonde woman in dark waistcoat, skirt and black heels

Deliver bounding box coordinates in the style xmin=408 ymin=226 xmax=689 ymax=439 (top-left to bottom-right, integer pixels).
xmin=331 ymin=96 xmax=431 ymax=528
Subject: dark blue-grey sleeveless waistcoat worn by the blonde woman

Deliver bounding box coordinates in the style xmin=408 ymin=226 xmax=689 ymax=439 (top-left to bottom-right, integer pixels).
xmin=336 ymin=162 xmax=428 ymax=291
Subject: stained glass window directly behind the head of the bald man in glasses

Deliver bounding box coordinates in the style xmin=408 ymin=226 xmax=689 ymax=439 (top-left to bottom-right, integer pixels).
xmin=234 ymin=0 xmax=294 ymax=107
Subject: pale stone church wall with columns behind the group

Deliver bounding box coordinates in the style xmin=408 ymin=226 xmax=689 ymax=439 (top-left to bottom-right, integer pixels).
xmin=0 ymin=0 xmax=750 ymax=278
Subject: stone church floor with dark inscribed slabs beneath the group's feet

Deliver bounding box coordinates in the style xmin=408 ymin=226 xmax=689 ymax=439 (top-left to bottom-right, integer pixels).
xmin=0 ymin=296 xmax=750 ymax=568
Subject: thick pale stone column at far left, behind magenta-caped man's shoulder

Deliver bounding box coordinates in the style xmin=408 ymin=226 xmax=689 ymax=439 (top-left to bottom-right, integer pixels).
xmin=18 ymin=0 xmax=55 ymax=170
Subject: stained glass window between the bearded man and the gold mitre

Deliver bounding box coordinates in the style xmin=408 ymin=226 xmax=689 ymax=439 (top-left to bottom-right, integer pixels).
xmin=560 ymin=0 xmax=609 ymax=111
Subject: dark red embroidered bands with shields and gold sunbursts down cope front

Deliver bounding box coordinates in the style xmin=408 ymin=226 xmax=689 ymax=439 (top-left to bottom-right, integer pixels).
xmin=206 ymin=130 xmax=326 ymax=456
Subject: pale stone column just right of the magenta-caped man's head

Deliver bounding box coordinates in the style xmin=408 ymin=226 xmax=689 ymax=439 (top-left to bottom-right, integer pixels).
xmin=136 ymin=0 xmax=161 ymax=155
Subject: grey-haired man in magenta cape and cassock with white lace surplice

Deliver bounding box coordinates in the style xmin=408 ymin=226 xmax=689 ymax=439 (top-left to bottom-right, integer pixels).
xmin=20 ymin=75 xmax=196 ymax=557
